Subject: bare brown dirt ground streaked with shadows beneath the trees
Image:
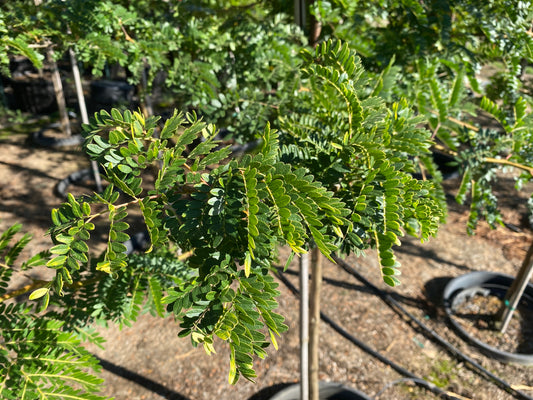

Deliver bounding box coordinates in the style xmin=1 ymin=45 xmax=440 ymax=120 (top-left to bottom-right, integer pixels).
xmin=0 ymin=122 xmax=533 ymax=400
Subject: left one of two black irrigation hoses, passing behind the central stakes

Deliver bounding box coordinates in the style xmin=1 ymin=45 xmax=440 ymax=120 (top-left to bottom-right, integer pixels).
xmin=272 ymin=269 xmax=460 ymax=400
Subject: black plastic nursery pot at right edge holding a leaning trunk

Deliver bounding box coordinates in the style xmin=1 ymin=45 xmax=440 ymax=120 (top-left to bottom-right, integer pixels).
xmin=443 ymin=271 xmax=533 ymax=366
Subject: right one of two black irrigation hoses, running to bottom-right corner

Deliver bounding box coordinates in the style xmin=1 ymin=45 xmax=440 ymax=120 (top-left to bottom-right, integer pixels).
xmin=333 ymin=255 xmax=533 ymax=400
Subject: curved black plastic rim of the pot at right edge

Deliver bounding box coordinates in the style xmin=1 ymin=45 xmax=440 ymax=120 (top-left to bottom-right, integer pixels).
xmin=443 ymin=271 xmax=533 ymax=366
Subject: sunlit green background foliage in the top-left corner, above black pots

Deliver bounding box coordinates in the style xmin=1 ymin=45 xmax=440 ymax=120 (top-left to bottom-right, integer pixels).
xmin=0 ymin=0 xmax=181 ymax=84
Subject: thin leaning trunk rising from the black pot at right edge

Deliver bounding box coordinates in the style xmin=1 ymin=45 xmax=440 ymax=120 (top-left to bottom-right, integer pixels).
xmin=495 ymin=242 xmax=533 ymax=333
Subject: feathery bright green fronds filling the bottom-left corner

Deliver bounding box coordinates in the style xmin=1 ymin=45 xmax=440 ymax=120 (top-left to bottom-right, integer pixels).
xmin=0 ymin=303 xmax=108 ymax=400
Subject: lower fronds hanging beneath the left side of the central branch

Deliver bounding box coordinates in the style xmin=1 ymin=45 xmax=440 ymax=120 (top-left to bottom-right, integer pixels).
xmin=49 ymin=249 xmax=195 ymax=330
